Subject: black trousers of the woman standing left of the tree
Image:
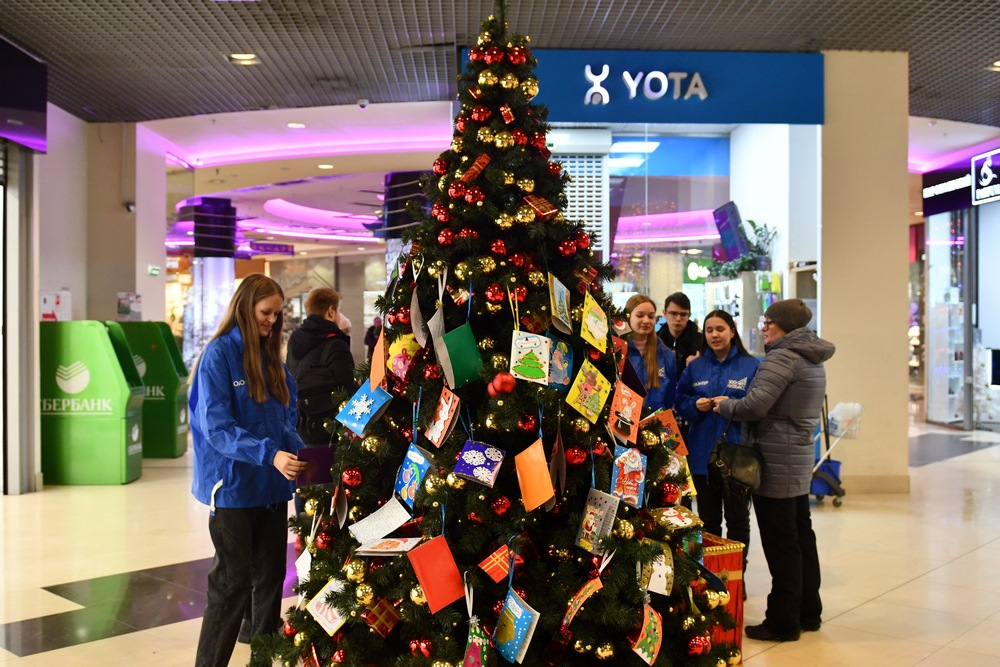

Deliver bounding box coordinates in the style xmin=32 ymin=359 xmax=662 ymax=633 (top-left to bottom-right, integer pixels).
xmin=195 ymin=503 xmax=288 ymax=667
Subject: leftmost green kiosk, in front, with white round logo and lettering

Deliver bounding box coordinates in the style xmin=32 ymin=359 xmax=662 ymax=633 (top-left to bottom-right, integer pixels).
xmin=39 ymin=320 xmax=145 ymax=484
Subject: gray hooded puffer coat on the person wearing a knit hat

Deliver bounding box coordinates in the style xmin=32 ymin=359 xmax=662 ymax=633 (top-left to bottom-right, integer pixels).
xmin=719 ymin=328 xmax=835 ymax=498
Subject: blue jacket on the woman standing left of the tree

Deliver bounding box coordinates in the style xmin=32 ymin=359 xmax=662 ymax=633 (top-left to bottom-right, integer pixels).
xmin=188 ymin=326 xmax=303 ymax=508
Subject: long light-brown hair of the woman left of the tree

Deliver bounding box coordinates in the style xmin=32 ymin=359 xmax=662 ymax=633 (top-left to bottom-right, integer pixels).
xmin=191 ymin=273 xmax=291 ymax=405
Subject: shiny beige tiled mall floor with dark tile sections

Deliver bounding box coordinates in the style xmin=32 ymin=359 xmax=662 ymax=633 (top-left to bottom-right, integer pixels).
xmin=0 ymin=427 xmax=1000 ymax=667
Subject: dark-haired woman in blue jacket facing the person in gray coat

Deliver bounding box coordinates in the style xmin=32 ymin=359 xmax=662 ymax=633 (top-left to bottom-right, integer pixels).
xmin=677 ymin=310 xmax=759 ymax=569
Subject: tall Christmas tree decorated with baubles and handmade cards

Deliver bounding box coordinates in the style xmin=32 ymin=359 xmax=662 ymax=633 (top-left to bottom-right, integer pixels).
xmin=251 ymin=2 xmax=740 ymax=667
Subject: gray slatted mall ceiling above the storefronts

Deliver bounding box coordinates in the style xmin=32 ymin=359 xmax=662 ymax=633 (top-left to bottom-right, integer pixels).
xmin=0 ymin=0 xmax=1000 ymax=126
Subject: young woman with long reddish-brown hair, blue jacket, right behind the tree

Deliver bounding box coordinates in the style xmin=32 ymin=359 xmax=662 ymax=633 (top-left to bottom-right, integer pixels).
xmin=625 ymin=294 xmax=677 ymax=411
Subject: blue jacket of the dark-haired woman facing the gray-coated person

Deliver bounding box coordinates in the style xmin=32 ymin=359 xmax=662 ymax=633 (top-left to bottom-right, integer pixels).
xmin=677 ymin=347 xmax=760 ymax=475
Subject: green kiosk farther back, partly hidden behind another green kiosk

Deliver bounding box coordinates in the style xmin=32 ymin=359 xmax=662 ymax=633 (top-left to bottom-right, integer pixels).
xmin=122 ymin=322 xmax=188 ymax=459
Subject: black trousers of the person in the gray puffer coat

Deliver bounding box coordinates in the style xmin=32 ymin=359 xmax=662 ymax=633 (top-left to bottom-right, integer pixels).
xmin=753 ymin=495 xmax=823 ymax=633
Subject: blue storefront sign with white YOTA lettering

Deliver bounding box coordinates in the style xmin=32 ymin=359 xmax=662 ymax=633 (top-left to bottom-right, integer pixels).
xmin=532 ymin=49 xmax=824 ymax=125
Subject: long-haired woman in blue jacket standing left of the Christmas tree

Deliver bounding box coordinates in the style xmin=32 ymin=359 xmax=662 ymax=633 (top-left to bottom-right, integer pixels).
xmin=188 ymin=273 xmax=306 ymax=667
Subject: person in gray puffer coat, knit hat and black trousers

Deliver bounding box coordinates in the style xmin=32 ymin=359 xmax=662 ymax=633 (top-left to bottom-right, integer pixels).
xmin=715 ymin=299 xmax=834 ymax=641
